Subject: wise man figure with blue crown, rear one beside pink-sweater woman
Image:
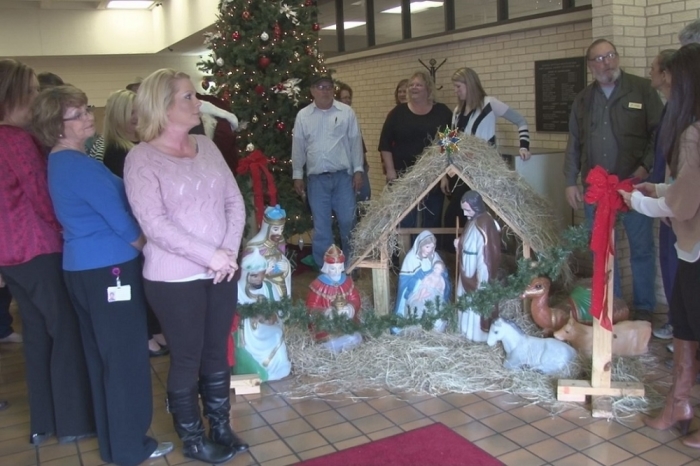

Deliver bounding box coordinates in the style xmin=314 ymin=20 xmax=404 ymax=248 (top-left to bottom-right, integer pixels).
xmin=246 ymin=205 xmax=292 ymax=297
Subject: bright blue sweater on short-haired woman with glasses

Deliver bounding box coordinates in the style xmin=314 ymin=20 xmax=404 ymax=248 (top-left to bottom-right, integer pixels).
xmin=49 ymin=150 xmax=141 ymax=271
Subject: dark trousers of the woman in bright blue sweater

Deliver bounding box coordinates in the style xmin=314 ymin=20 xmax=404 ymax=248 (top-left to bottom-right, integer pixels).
xmin=65 ymin=259 xmax=157 ymax=466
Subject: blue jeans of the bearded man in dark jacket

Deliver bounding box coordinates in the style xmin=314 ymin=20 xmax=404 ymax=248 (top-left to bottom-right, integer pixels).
xmin=584 ymin=204 xmax=656 ymax=312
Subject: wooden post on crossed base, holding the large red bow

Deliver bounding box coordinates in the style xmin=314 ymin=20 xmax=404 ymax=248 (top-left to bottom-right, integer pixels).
xmin=557 ymin=235 xmax=644 ymax=419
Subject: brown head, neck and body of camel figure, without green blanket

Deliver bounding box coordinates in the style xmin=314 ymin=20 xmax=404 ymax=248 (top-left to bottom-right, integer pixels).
xmin=520 ymin=277 xmax=629 ymax=337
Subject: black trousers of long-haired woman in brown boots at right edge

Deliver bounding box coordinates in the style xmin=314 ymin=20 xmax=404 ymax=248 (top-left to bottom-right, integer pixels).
xmin=669 ymin=259 xmax=700 ymax=341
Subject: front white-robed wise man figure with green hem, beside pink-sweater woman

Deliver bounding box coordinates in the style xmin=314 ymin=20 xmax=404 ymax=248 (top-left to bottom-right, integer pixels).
xmin=234 ymin=248 xmax=292 ymax=382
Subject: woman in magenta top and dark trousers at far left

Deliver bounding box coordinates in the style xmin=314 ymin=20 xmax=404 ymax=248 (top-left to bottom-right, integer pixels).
xmin=0 ymin=60 xmax=94 ymax=445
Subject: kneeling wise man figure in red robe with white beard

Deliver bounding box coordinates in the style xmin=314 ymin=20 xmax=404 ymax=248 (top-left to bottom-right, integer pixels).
xmin=306 ymin=245 xmax=362 ymax=353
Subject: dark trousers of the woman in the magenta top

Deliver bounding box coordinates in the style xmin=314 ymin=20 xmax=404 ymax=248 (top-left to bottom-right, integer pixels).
xmin=0 ymin=253 xmax=95 ymax=437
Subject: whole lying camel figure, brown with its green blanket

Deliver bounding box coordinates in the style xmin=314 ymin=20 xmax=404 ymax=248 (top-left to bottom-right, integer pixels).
xmin=520 ymin=277 xmax=630 ymax=336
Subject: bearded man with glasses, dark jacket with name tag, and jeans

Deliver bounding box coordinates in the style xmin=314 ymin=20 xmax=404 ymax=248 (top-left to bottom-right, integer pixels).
xmin=564 ymin=39 xmax=662 ymax=321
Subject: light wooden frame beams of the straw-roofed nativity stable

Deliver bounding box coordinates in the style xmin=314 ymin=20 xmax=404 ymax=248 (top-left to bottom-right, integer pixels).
xmin=347 ymin=164 xmax=532 ymax=315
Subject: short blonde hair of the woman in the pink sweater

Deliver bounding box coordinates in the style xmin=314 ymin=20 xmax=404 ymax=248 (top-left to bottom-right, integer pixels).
xmin=136 ymin=68 xmax=190 ymax=142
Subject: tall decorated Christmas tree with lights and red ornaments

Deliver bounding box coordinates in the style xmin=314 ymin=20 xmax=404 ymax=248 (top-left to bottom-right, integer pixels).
xmin=200 ymin=0 xmax=327 ymax=234
